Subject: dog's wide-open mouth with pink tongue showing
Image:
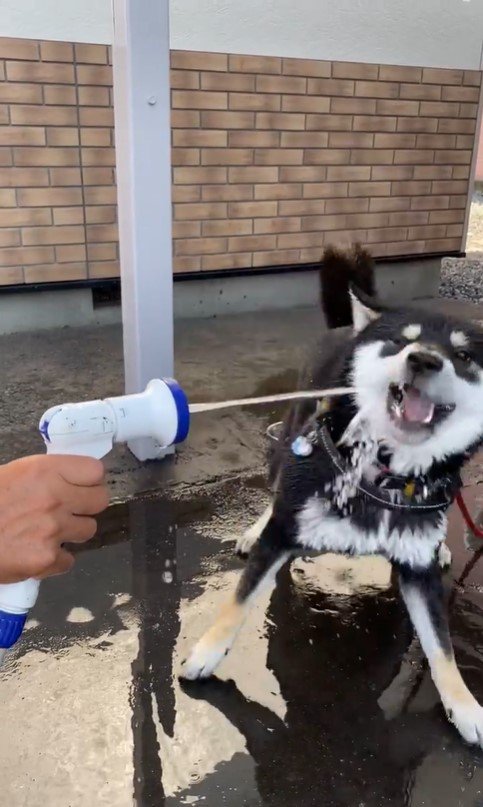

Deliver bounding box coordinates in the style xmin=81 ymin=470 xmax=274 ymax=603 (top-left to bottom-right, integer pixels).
xmin=387 ymin=384 xmax=455 ymax=431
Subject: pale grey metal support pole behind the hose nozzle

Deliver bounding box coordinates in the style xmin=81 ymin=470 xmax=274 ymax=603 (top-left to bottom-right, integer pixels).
xmin=113 ymin=0 xmax=173 ymax=460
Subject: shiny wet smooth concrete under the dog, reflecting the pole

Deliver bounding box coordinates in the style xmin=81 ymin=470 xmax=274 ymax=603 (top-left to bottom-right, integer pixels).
xmin=0 ymin=477 xmax=483 ymax=807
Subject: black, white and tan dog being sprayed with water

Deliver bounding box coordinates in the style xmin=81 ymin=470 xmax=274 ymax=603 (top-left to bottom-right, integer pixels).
xmin=183 ymin=248 xmax=483 ymax=746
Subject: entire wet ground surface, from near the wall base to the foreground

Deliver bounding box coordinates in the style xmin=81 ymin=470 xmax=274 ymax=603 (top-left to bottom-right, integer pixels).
xmin=0 ymin=300 xmax=483 ymax=807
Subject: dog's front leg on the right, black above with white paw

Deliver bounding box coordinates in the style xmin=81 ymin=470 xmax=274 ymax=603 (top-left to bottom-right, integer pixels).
xmin=398 ymin=562 xmax=483 ymax=747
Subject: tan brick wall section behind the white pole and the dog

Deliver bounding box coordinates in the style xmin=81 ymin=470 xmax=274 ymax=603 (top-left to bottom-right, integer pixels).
xmin=0 ymin=39 xmax=481 ymax=284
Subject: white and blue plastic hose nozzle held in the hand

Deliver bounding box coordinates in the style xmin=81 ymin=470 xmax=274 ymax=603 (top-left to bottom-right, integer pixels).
xmin=0 ymin=378 xmax=190 ymax=663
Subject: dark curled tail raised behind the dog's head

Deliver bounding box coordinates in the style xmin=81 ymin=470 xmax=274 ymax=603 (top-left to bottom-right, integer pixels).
xmin=320 ymin=244 xmax=375 ymax=328
